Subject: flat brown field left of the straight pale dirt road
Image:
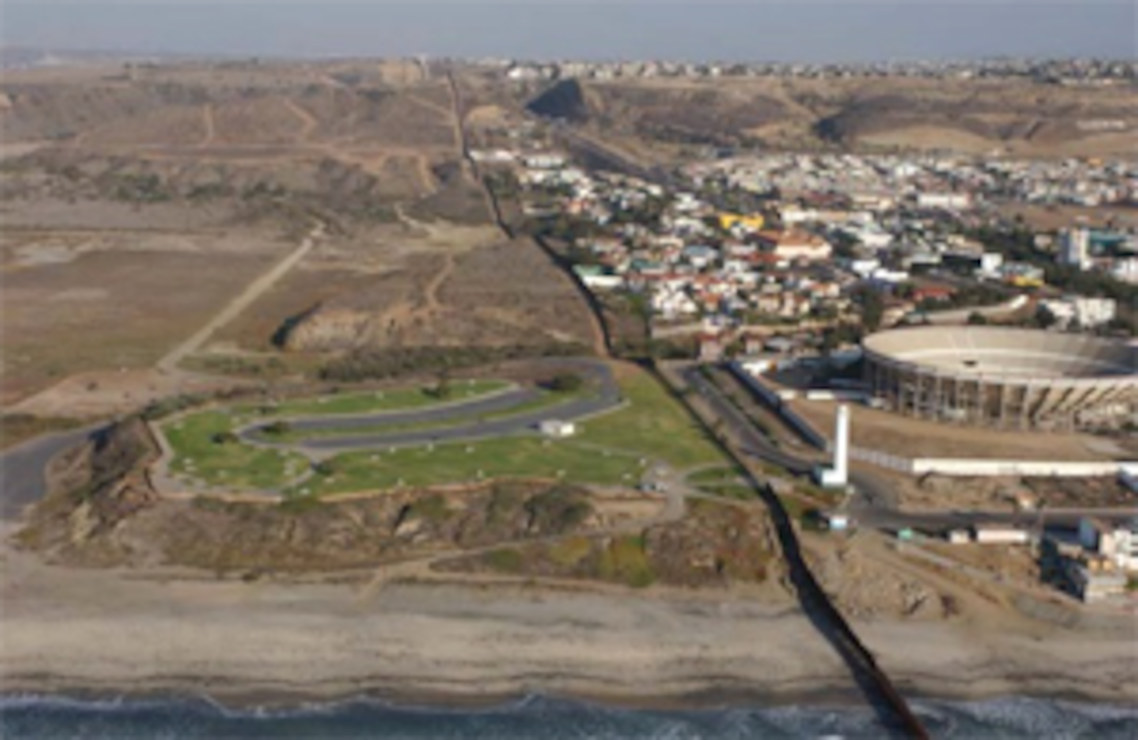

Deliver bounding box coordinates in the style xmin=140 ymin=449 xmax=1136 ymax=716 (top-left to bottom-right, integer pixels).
xmin=0 ymin=231 xmax=291 ymax=404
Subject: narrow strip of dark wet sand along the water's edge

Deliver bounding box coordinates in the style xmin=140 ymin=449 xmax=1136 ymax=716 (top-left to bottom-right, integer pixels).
xmin=0 ymin=660 xmax=1138 ymax=714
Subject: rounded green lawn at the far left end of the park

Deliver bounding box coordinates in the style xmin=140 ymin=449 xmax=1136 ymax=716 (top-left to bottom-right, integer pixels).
xmin=164 ymin=411 xmax=308 ymax=491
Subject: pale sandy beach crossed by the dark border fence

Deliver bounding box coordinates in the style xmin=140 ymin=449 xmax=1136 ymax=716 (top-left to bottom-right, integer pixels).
xmin=0 ymin=519 xmax=1138 ymax=706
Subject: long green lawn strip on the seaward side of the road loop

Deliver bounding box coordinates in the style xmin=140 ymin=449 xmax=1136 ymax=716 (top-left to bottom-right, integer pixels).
xmin=290 ymin=437 xmax=644 ymax=495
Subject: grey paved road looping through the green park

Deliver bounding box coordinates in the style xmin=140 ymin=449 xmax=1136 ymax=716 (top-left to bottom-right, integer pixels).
xmin=242 ymin=360 xmax=622 ymax=455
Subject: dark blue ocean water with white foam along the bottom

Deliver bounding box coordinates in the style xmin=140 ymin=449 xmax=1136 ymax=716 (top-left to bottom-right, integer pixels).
xmin=0 ymin=697 xmax=1138 ymax=740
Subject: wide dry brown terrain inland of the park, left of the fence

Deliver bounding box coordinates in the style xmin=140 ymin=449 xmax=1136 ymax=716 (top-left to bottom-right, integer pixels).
xmin=0 ymin=60 xmax=594 ymax=417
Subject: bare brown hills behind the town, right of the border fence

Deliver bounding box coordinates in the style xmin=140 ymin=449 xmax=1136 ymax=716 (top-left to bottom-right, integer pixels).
xmin=529 ymin=77 xmax=1138 ymax=157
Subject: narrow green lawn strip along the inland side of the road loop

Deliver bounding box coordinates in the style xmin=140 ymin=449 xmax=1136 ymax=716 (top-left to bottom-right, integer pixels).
xmin=237 ymin=380 xmax=510 ymax=418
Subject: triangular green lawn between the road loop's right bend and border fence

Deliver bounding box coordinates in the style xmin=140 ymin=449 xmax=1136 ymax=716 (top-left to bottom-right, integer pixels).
xmin=580 ymin=367 xmax=728 ymax=470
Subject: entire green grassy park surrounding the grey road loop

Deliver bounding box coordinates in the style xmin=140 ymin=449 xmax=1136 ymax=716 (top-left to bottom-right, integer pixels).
xmin=164 ymin=367 xmax=727 ymax=496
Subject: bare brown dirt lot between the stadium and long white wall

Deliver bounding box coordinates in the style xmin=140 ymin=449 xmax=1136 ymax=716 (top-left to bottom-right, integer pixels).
xmin=791 ymin=401 xmax=1128 ymax=462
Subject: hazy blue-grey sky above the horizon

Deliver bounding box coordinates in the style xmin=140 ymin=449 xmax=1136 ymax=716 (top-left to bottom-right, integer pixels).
xmin=0 ymin=0 xmax=1138 ymax=61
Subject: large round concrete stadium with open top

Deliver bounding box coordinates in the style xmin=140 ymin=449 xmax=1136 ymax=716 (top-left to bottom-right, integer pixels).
xmin=863 ymin=327 xmax=1138 ymax=429
